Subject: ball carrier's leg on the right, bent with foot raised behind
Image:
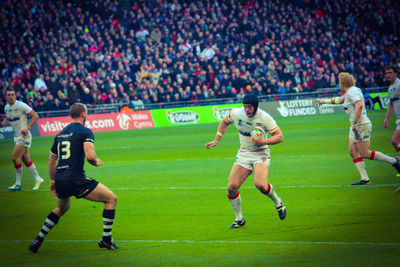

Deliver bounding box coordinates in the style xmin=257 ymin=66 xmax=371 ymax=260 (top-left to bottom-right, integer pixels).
xmin=254 ymin=163 xmax=286 ymax=220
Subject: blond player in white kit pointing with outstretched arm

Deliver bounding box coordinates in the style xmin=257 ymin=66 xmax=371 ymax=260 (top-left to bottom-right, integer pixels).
xmin=317 ymin=72 xmax=400 ymax=185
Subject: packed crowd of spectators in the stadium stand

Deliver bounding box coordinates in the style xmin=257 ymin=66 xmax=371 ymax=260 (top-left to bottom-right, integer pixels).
xmin=0 ymin=0 xmax=400 ymax=113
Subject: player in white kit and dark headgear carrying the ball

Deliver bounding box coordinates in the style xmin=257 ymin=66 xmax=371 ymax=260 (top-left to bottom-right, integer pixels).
xmin=206 ymin=95 xmax=286 ymax=229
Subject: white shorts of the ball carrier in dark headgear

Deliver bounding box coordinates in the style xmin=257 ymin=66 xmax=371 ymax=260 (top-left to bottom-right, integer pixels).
xmin=234 ymin=148 xmax=271 ymax=171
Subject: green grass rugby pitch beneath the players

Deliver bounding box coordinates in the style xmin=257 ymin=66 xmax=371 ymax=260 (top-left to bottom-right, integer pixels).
xmin=0 ymin=111 xmax=400 ymax=266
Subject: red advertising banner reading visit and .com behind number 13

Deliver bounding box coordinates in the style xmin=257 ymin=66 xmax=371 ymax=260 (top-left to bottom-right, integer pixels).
xmin=37 ymin=110 xmax=154 ymax=136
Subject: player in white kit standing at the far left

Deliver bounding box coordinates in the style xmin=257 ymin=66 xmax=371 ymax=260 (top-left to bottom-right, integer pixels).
xmin=0 ymin=89 xmax=43 ymax=191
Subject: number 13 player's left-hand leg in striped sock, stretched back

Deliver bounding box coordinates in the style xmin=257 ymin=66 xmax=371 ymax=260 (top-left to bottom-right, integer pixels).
xmin=29 ymin=197 xmax=71 ymax=253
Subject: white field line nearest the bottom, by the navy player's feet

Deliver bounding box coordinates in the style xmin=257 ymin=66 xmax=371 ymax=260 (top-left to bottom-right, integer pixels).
xmin=5 ymin=239 xmax=400 ymax=247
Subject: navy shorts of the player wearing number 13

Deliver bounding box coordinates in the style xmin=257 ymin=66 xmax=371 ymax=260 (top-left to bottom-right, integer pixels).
xmin=56 ymin=177 xmax=99 ymax=198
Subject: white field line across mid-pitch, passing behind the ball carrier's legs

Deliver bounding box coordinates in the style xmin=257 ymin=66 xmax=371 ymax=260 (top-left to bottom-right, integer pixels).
xmin=0 ymin=183 xmax=400 ymax=193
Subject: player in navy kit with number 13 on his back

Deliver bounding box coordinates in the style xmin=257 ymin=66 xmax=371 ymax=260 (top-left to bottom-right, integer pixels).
xmin=29 ymin=103 xmax=118 ymax=252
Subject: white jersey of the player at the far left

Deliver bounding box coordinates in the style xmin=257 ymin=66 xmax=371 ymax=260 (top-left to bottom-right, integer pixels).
xmin=4 ymin=100 xmax=32 ymax=136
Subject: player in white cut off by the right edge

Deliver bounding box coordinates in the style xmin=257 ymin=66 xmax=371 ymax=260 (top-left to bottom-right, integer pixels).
xmin=383 ymin=66 xmax=400 ymax=159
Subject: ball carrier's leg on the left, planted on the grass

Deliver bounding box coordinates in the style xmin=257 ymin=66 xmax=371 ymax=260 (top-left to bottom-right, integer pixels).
xmin=228 ymin=164 xmax=251 ymax=228
